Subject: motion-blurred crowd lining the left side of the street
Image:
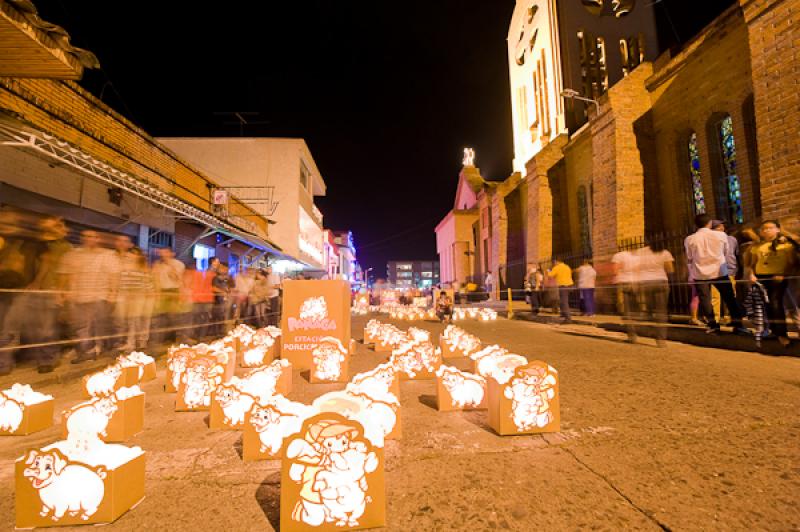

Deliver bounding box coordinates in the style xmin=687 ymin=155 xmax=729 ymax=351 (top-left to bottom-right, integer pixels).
xmin=0 ymin=209 xmax=281 ymax=375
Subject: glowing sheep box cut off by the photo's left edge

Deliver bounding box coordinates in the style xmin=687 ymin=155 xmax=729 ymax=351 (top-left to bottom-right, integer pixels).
xmin=0 ymin=383 xmax=53 ymax=436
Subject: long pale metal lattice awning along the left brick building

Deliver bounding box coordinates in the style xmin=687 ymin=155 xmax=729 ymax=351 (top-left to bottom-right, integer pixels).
xmin=0 ymin=122 xmax=283 ymax=256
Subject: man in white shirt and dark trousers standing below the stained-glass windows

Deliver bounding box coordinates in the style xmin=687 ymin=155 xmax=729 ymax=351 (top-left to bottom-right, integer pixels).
xmin=684 ymin=214 xmax=749 ymax=334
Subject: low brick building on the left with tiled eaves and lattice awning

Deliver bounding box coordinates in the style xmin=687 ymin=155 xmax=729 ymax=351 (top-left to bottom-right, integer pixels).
xmin=0 ymin=0 xmax=281 ymax=268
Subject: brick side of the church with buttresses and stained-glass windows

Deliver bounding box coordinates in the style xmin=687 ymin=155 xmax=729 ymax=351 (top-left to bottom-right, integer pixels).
xmin=478 ymin=0 xmax=800 ymax=302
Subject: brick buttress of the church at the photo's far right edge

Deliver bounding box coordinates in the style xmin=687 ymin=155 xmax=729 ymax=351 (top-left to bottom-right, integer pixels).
xmin=739 ymin=0 xmax=800 ymax=228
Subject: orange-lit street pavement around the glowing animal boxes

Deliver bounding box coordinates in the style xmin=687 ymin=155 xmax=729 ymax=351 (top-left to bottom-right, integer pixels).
xmin=0 ymin=316 xmax=800 ymax=531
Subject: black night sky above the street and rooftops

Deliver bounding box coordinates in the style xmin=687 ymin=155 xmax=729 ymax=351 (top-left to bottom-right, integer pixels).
xmin=29 ymin=0 xmax=732 ymax=274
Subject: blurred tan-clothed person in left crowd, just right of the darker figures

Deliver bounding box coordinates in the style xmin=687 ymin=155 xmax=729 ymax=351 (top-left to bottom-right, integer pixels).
xmin=60 ymin=230 xmax=120 ymax=364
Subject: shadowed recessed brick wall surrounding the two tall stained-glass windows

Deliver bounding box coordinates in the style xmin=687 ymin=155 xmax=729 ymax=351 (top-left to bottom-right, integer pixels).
xmin=645 ymin=6 xmax=760 ymax=231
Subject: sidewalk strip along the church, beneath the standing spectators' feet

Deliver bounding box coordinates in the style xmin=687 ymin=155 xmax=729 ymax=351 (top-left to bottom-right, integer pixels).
xmin=465 ymin=301 xmax=800 ymax=357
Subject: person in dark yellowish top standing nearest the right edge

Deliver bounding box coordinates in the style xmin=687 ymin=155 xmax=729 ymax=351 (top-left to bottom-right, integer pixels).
xmin=750 ymin=220 xmax=800 ymax=347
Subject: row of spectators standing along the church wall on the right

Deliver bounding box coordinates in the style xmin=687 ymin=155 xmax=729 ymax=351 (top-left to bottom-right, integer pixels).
xmin=525 ymin=214 xmax=800 ymax=347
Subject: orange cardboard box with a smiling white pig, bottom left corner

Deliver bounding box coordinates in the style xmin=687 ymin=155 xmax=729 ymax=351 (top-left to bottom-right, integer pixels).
xmin=15 ymin=446 xmax=145 ymax=528
